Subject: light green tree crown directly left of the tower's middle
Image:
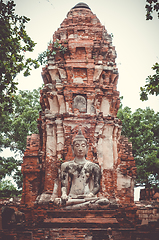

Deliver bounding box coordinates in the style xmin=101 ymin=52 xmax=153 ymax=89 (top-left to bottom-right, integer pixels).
xmin=0 ymin=89 xmax=41 ymax=153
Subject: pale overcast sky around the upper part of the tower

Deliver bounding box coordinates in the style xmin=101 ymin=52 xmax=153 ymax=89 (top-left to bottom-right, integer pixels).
xmin=12 ymin=0 xmax=159 ymax=111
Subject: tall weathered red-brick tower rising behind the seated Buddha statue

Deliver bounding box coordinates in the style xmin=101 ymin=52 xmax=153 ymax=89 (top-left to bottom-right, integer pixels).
xmin=20 ymin=3 xmax=135 ymax=206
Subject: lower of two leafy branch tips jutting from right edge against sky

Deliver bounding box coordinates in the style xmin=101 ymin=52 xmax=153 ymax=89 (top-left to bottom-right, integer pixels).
xmin=140 ymin=63 xmax=159 ymax=101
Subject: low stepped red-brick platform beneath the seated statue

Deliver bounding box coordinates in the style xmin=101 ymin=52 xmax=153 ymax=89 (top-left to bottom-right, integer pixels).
xmin=0 ymin=202 xmax=159 ymax=240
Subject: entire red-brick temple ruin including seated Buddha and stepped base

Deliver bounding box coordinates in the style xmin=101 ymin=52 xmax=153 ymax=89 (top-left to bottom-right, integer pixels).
xmin=1 ymin=3 xmax=159 ymax=240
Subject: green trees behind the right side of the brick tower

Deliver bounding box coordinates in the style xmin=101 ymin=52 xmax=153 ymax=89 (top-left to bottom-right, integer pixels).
xmin=117 ymin=107 xmax=159 ymax=187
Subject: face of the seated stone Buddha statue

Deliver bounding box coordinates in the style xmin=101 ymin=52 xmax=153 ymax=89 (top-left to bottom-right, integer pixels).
xmin=73 ymin=140 xmax=87 ymax=158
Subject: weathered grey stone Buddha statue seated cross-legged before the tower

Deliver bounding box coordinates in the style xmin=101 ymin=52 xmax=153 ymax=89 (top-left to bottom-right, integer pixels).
xmin=54 ymin=130 xmax=109 ymax=209
